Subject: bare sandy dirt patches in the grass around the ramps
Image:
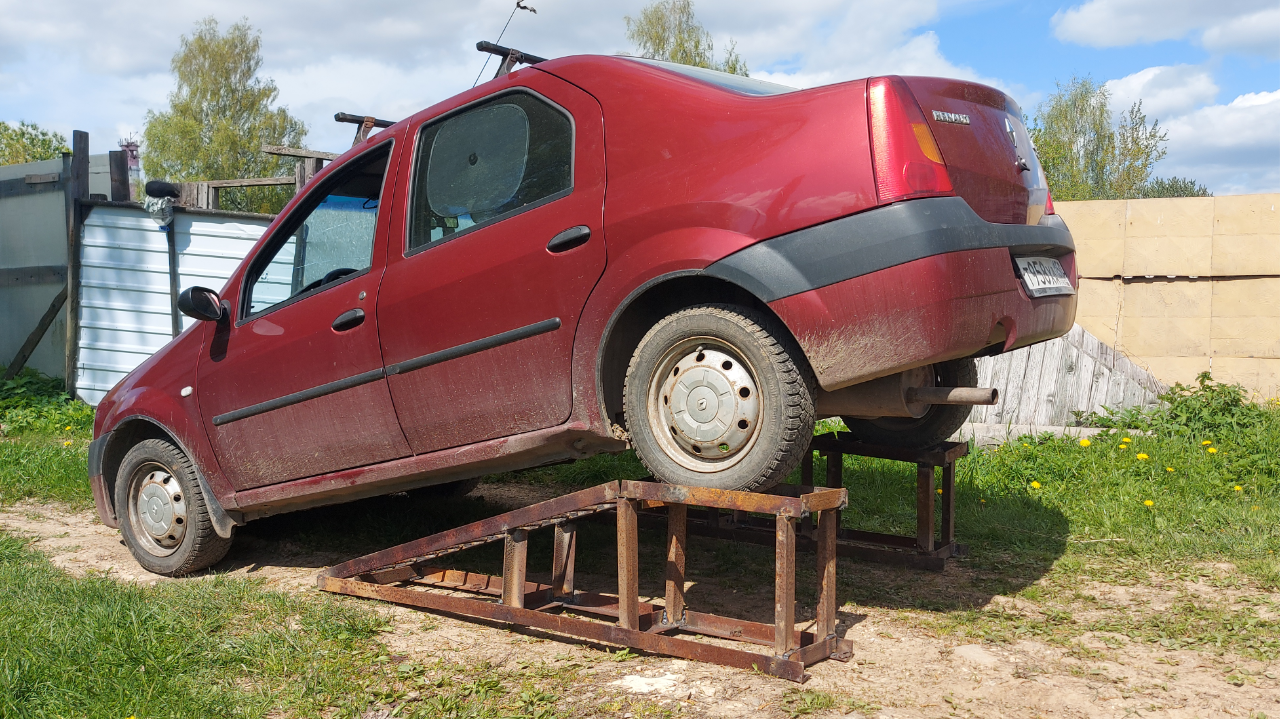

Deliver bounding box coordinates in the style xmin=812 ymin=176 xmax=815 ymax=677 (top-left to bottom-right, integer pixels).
xmin=0 ymin=486 xmax=1280 ymax=717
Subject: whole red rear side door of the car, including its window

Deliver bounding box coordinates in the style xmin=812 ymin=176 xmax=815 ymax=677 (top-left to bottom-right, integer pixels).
xmin=378 ymin=72 xmax=605 ymax=452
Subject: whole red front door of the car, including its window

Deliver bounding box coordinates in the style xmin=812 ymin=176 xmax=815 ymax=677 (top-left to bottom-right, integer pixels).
xmin=197 ymin=138 xmax=410 ymax=489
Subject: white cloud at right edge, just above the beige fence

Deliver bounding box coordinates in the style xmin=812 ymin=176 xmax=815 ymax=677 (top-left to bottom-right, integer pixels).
xmin=1156 ymin=90 xmax=1280 ymax=195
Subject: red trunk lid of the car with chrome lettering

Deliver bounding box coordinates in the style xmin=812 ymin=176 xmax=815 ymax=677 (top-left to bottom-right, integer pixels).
xmin=902 ymin=77 xmax=1048 ymax=224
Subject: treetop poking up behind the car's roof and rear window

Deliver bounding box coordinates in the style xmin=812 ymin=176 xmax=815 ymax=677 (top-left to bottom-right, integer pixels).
xmin=623 ymin=0 xmax=748 ymax=77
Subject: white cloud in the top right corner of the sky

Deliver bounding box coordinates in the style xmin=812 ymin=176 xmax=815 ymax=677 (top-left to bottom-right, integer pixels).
xmin=1052 ymin=0 xmax=1280 ymax=55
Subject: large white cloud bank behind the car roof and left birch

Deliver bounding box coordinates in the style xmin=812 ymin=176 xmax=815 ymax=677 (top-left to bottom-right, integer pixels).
xmin=0 ymin=0 xmax=1007 ymax=152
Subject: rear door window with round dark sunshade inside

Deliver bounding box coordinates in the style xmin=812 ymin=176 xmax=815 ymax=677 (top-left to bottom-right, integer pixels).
xmin=408 ymin=92 xmax=573 ymax=251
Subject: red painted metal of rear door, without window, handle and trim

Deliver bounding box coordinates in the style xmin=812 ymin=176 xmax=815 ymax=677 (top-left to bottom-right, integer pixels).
xmin=378 ymin=72 xmax=605 ymax=454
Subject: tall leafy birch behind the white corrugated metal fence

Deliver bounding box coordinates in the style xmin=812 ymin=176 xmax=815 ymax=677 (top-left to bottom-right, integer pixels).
xmin=142 ymin=17 xmax=307 ymax=213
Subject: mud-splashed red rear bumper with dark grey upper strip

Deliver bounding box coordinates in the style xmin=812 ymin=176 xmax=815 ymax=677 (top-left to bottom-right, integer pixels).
xmin=708 ymin=197 xmax=1076 ymax=391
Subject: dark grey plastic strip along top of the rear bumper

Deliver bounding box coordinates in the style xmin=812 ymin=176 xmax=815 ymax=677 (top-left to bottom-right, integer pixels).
xmin=704 ymin=197 xmax=1075 ymax=302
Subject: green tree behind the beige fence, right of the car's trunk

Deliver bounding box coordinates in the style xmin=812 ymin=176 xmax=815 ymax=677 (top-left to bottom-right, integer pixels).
xmin=1030 ymin=77 xmax=1208 ymax=200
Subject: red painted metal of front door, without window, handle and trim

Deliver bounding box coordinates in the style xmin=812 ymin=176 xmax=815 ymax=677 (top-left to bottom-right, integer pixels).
xmin=197 ymin=134 xmax=411 ymax=489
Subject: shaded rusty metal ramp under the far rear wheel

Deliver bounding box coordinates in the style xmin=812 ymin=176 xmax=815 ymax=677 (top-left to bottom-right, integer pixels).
xmin=670 ymin=433 xmax=969 ymax=573
